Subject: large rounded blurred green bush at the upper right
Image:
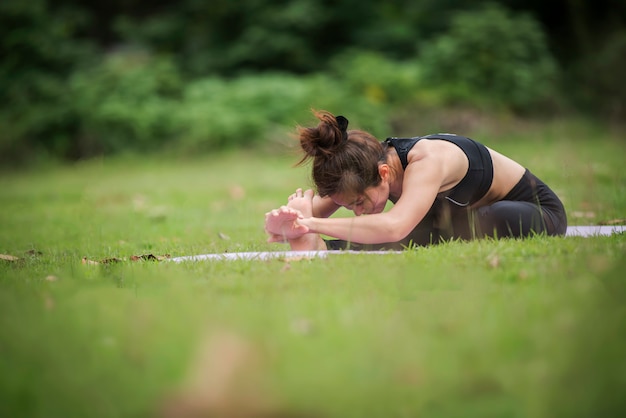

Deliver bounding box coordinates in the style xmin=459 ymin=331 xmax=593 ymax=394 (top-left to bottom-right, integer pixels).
xmin=421 ymin=5 xmax=558 ymax=111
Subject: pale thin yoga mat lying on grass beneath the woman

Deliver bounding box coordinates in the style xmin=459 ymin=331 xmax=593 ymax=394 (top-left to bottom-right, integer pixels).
xmin=170 ymin=225 xmax=626 ymax=263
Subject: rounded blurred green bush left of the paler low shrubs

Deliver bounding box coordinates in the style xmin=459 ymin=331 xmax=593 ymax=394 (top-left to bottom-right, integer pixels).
xmin=69 ymin=51 xmax=183 ymax=155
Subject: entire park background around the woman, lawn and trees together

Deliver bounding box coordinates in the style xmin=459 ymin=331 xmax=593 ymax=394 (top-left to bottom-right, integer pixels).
xmin=0 ymin=0 xmax=626 ymax=418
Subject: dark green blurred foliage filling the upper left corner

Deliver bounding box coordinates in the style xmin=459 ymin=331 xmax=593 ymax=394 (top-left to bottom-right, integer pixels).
xmin=0 ymin=0 xmax=95 ymax=160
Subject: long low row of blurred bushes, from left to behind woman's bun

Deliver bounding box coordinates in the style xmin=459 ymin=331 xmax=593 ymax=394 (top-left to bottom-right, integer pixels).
xmin=64 ymin=51 xmax=388 ymax=156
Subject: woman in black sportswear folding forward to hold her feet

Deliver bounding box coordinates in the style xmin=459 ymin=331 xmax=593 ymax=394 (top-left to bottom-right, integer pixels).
xmin=265 ymin=111 xmax=567 ymax=250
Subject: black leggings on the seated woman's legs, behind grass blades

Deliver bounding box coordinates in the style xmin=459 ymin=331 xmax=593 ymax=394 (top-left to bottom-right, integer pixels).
xmin=326 ymin=170 xmax=567 ymax=250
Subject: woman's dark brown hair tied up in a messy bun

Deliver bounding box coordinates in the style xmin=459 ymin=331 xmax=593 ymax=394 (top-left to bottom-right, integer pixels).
xmin=298 ymin=111 xmax=386 ymax=197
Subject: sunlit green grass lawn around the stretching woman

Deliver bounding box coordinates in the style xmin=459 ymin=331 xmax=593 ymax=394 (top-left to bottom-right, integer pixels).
xmin=0 ymin=124 xmax=626 ymax=417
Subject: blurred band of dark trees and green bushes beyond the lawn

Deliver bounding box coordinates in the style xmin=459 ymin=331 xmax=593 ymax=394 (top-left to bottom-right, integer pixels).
xmin=0 ymin=0 xmax=626 ymax=167
